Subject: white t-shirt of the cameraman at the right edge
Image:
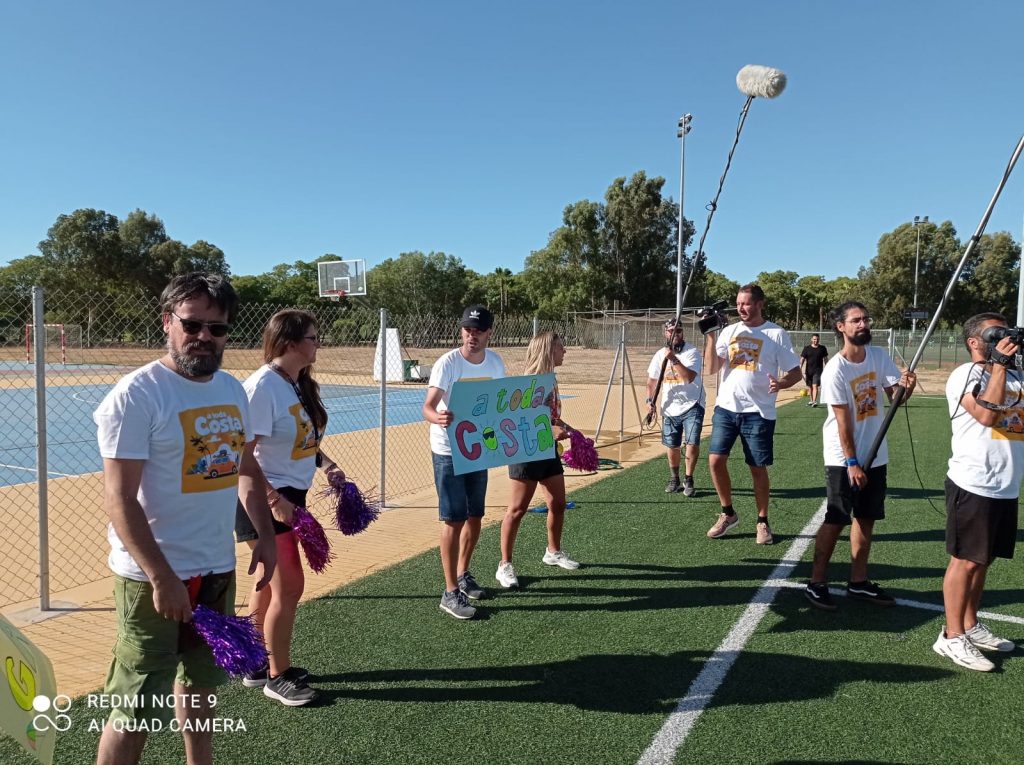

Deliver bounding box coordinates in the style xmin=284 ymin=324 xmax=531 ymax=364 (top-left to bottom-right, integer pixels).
xmin=946 ymin=364 xmax=1024 ymax=500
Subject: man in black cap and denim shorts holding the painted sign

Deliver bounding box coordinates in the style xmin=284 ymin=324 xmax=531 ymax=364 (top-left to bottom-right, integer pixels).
xmin=423 ymin=305 xmax=505 ymax=619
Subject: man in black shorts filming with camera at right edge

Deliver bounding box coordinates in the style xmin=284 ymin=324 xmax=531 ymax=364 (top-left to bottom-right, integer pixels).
xmin=932 ymin=313 xmax=1024 ymax=672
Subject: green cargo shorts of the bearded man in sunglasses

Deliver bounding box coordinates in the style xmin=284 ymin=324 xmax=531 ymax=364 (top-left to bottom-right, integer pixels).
xmin=103 ymin=571 xmax=234 ymax=726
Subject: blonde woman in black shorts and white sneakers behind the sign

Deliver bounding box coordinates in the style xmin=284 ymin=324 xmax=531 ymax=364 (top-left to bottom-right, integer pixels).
xmin=495 ymin=332 xmax=580 ymax=589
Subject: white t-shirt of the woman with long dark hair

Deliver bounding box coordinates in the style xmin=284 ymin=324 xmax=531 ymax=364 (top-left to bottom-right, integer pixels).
xmin=243 ymin=365 xmax=323 ymax=488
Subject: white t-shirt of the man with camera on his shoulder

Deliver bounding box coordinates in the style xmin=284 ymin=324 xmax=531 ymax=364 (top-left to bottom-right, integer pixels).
xmin=715 ymin=322 xmax=800 ymax=420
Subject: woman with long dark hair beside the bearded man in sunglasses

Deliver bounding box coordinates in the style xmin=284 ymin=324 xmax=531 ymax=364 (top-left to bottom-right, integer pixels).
xmin=234 ymin=309 xmax=338 ymax=707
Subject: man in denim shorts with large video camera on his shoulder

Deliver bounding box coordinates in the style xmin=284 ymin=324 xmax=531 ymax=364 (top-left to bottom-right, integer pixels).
xmin=705 ymin=284 xmax=800 ymax=545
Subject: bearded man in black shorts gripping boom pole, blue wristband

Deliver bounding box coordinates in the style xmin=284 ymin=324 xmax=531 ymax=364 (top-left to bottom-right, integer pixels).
xmin=804 ymin=300 xmax=918 ymax=611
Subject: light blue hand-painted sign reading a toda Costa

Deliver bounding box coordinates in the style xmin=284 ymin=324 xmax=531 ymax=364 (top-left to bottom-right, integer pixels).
xmin=447 ymin=374 xmax=555 ymax=475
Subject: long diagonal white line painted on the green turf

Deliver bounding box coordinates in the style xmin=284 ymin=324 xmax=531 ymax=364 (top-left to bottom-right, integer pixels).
xmin=637 ymin=502 xmax=825 ymax=765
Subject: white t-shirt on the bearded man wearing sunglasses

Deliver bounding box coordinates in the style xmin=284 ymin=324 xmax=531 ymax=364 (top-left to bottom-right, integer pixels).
xmin=92 ymin=362 xmax=249 ymax=582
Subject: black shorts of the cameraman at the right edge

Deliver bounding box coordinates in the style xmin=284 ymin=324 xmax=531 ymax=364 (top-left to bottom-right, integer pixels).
xmin=946 ymin=477 xmax=1017 ymax=565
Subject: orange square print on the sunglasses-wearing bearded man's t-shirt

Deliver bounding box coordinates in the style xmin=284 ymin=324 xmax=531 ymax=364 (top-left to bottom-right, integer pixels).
xmin=178 ymin=403 xmax=246 ymax=494
